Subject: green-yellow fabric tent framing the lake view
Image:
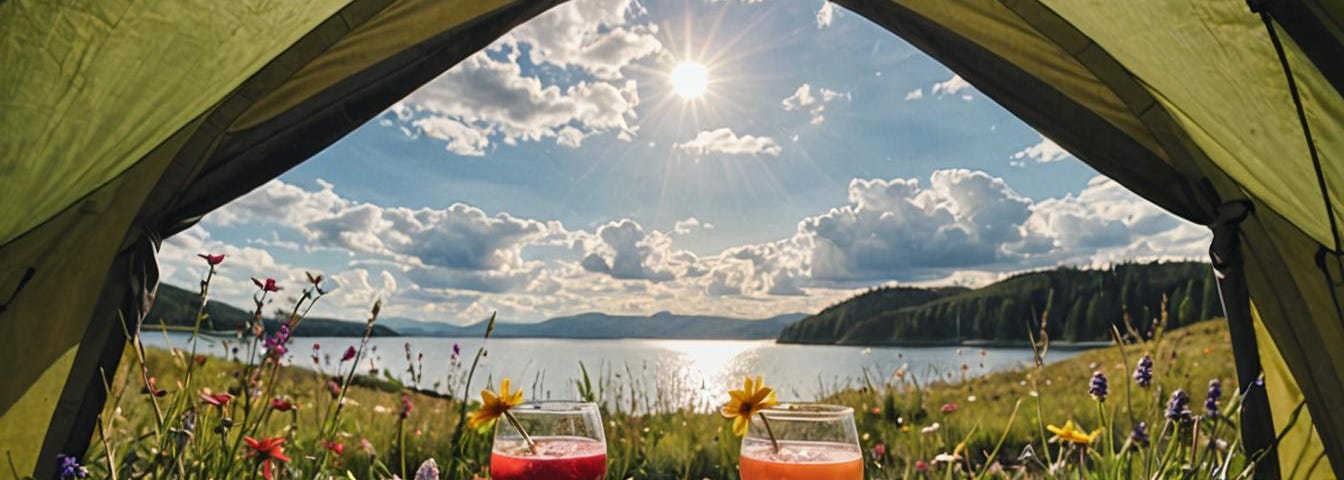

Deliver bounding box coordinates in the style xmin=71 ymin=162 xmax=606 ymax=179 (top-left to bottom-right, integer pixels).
xmin=0 ymin=0 xmax=1344 ymax=479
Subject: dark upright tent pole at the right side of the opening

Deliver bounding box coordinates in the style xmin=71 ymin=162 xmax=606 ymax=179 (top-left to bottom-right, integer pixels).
xmin=1208 ymin=200 xmax=1281 ymax=479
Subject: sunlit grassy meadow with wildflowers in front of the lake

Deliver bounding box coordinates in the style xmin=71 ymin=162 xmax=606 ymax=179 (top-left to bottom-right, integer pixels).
xmin=83 ymin=311 xmax=1245 ymax=479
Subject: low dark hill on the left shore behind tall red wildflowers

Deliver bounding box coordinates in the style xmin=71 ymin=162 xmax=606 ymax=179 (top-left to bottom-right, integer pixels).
xmin=145 ymin=284 xmax=396 ymax=336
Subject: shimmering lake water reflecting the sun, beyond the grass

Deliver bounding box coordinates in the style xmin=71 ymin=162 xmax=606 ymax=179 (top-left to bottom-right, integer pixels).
xmin=144 ymin=332 xmax=1074 ymax=411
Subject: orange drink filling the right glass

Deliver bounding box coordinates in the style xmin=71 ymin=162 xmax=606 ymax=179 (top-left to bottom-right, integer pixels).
xmin=739 ymin=441 xmax=863 ymax=480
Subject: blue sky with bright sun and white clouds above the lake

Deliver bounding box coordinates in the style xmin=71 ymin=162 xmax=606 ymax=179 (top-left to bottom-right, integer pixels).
xmin=160 ymin=0 xmax=1210 ymax=324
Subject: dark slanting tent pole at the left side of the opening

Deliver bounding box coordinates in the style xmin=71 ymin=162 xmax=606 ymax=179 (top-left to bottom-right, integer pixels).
xmin=34 ymin=231 xmax=159 ymax=479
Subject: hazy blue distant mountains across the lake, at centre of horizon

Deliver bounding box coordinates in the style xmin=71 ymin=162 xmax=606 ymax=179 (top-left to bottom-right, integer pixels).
xmin=387 ymin=307 xmax=806 ymax=340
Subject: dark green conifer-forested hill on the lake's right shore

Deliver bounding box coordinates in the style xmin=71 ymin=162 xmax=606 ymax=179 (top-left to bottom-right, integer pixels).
xmin=778 ymin=262 xmax=1222 ymax=346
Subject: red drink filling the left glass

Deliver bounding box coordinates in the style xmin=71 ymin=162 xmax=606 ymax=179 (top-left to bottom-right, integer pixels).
xmin=491 ymin=437 xmax=606 ymax=480
